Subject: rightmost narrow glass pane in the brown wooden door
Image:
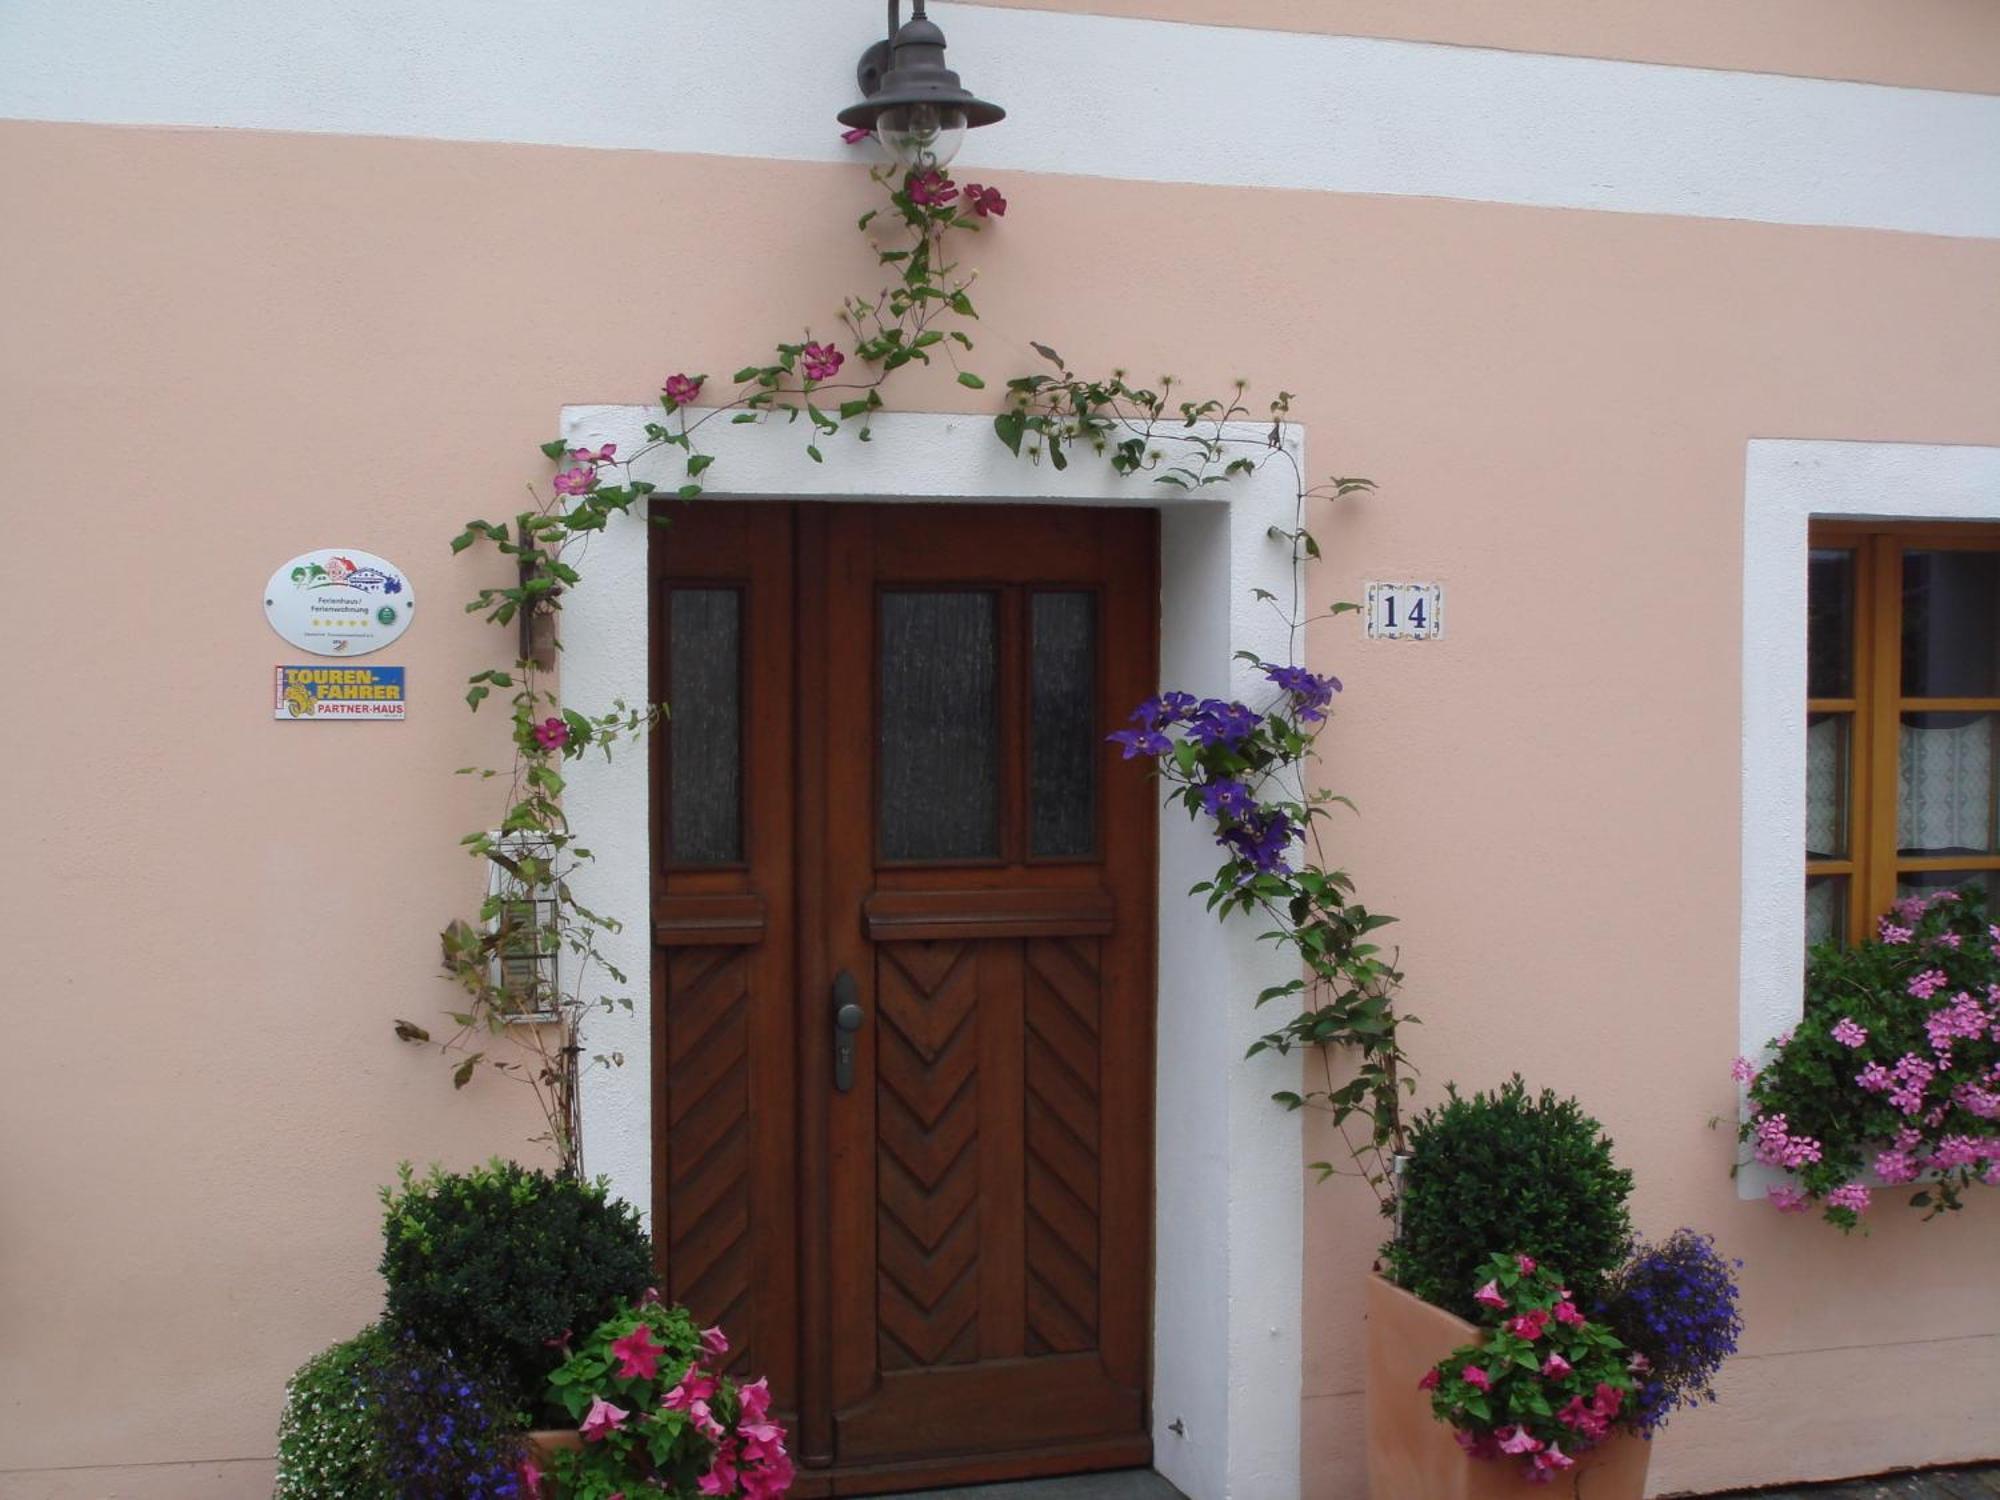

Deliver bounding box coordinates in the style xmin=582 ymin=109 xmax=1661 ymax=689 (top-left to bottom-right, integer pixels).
xmin=1028 ymin=592 xmax=1098 ymax=854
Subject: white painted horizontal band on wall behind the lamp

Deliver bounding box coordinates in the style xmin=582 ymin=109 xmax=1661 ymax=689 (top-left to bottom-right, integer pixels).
xmin=0 ymin=0 xmax=2000 ymax=238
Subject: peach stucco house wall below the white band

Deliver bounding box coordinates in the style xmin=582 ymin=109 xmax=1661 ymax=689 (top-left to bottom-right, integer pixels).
xmin=0 ymin=85 xmax=2000 ymax=1500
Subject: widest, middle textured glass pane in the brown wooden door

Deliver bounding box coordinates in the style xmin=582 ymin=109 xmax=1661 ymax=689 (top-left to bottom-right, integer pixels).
xmin=876 ymin=590 xmax=1000 ymax=860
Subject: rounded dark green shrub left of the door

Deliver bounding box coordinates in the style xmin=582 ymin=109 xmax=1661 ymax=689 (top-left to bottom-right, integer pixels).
xmin=382 ymin=1160 xmax=652 ymax=1408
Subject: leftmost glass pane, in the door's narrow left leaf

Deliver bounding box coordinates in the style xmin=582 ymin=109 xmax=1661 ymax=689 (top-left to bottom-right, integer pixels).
xmin=666 ymin=588 xmax=744 ymax=864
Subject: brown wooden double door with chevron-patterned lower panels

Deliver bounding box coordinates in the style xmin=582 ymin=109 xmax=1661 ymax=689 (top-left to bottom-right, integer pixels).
xmin=652 ymin=502 xmax=1158 ymax=1496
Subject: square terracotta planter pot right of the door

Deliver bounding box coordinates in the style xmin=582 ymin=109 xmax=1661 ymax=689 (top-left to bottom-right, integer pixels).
xmin=1368 ymin=1276 xmax=1652 ymax=1500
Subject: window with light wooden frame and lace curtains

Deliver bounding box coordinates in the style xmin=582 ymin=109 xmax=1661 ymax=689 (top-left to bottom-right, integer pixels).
xmin=1806 ymin=522 xmax=2000 ymax=942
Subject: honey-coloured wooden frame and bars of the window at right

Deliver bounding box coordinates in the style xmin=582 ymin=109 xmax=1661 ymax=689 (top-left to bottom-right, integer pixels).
xmin=1806 ymin=520 xmax=2000 ymax=942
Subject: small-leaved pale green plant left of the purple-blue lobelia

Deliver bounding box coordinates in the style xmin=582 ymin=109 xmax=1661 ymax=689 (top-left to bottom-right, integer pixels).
xmin=272 ymin=1326 xmax=398 ymax=1500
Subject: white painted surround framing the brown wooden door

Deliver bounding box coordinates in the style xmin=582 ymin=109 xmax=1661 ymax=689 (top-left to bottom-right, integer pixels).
xmin=562 ymin=406 xmax=1304 ymax=1500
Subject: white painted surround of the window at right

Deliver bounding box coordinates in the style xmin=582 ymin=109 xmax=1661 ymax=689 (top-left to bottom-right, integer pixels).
xmin=1736 ymin=438 xmax=2000 ymax=1198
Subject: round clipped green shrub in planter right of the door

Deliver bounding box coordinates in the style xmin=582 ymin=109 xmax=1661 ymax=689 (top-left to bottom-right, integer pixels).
xmin=1382 ymin=1074 xmax=1632 ymax=1318
